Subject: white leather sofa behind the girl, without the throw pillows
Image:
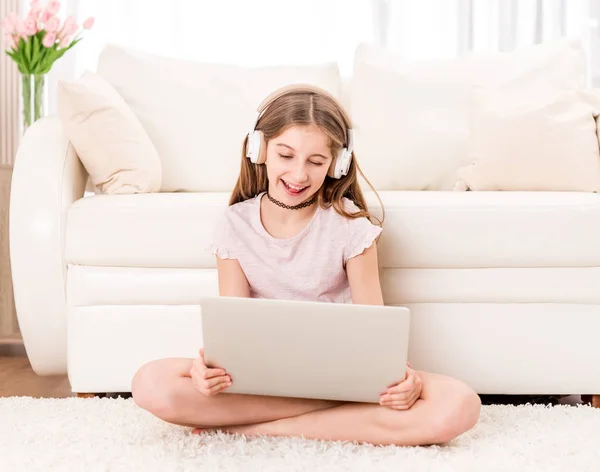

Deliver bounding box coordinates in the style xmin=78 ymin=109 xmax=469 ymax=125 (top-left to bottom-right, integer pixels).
xmin=10 ymin=41 xmax=600 ymax=402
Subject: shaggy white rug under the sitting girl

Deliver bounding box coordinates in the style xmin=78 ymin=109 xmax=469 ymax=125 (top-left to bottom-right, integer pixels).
xmin=0 ymin=397 xmax=600 ymax=472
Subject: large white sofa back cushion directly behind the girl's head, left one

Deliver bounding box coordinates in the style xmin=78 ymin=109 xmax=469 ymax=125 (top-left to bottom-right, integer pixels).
xmin=98 ymin=45 xmax=341 ymax=192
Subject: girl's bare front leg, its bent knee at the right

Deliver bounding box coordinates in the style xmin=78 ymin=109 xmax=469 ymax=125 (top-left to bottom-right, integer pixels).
xmin=221 ymin=372 xmax=481 ymax=446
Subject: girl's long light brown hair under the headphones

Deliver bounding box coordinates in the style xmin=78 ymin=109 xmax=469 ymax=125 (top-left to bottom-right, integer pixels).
xmin=229 ymin=90 xmax=385 ymax=230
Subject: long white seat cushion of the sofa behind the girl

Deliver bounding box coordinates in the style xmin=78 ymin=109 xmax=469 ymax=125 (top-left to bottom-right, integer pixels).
xmin=65 ymin=191 xmax=600 ymax=268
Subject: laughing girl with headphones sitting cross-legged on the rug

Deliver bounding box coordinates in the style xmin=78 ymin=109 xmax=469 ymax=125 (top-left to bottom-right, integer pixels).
xmin=132 ymin=82 xmax=481 ymax=445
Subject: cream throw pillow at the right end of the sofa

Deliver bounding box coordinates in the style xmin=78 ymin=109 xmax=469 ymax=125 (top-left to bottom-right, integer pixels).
xmin=457 ymin=89 xmax=600 ymax=192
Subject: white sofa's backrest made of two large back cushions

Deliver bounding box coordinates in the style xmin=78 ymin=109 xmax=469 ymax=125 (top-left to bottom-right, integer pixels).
xmin=97 ymin=40 xmax=587 ymax=192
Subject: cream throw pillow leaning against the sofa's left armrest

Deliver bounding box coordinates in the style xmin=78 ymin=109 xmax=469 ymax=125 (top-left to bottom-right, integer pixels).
xmin=58 ymin=72 xmax=161 ymax=194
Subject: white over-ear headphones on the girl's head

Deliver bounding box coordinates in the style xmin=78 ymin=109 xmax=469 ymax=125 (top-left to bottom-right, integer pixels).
xmin=246 ymin=84 xmax=354 ymax=179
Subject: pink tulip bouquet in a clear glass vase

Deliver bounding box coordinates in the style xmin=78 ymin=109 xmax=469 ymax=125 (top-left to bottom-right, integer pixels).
xmin=2 ymin=0 xmax=94 ymax=129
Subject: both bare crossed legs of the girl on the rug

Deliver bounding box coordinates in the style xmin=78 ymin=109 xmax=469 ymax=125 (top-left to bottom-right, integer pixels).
xmin=132 ymin=359 xmax=481 ymax=446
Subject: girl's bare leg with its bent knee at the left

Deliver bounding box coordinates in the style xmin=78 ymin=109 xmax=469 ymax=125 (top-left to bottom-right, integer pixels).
xmin=131 ymin=359 xmax=342 ymax=428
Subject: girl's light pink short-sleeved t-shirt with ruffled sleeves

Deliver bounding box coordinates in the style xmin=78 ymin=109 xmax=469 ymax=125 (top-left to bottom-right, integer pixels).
xmin=211 ymin=192 xmax=381 ymax=303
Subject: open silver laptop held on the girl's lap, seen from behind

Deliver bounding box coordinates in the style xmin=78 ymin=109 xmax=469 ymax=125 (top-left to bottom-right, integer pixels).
xmin=200 ymin=297 xmax=410 ymax=403
